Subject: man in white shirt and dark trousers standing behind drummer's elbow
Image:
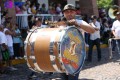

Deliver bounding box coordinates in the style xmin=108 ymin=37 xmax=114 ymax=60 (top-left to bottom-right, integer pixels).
xmin=87 ymin=15 xmax=101 ymax=62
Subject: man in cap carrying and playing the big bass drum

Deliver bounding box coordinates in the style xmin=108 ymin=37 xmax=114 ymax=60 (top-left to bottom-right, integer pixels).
xmin=59 ymin=4 xmax=95 ymax=80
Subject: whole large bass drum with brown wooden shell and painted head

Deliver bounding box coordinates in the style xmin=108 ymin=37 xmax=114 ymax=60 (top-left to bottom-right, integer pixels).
xmin=25 ymin=26 xmax=86 ymax=75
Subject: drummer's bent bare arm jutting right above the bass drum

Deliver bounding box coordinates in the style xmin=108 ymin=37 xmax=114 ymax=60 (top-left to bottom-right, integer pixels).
xmin=75 ymin=22 xmax=95 ymax=33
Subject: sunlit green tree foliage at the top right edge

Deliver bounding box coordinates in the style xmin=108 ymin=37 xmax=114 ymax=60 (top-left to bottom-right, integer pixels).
xmin=97 ymin=0 xmax=113 ymax=9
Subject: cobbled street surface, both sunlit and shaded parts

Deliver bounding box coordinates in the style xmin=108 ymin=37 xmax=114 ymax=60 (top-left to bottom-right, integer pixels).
xmin=0 ymin=48 xmax=120 ymax=80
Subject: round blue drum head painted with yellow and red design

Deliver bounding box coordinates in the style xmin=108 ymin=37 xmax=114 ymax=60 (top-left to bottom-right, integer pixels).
xmin=60 ymin=27 xmax=86 ymax=74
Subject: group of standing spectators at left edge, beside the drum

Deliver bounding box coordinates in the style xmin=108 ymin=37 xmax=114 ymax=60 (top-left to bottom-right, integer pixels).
xmin=0 ymin=12 xmax=24 ymax=73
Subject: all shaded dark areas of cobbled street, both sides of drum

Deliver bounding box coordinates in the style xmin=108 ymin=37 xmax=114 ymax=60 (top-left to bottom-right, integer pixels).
xmin=0 ymin=48 xmax=120 ymax=80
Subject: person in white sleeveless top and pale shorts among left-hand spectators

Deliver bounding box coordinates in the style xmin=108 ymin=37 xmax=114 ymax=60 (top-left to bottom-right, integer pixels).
xmin=3 ymin=17 xmax=17 ymax=71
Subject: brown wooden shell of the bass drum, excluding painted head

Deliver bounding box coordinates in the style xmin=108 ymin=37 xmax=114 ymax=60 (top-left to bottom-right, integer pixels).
xmin=25 ymin=28 xmax=64 ymax=72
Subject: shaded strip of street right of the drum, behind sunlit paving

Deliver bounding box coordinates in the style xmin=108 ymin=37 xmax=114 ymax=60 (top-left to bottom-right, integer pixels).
xmin=82 ymin=48 xmax=120 ymax=70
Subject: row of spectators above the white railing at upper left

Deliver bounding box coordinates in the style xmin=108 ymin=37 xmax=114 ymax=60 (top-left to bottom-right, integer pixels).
xmin=15 ymin=0 xmax=80 ymax=15
